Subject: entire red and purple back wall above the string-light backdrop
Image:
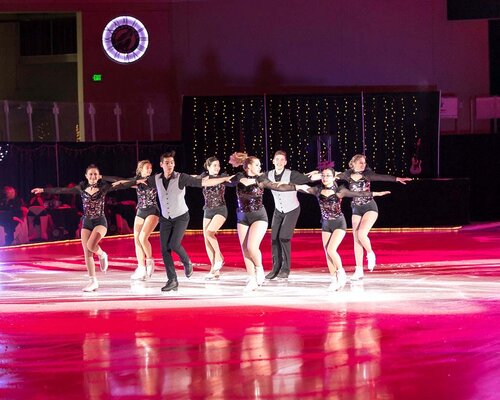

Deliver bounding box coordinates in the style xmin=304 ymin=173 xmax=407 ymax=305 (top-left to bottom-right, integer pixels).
xmin=0 ymin=0 xmax=489 ymax=140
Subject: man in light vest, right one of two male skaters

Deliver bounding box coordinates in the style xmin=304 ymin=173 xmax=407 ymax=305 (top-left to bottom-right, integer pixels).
xmin=266 ymin=150 xmax=311 ymax=279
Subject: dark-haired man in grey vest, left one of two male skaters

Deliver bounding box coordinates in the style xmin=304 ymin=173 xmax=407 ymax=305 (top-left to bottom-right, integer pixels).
xmin=147 ymin=151 xmax=232 ymax=292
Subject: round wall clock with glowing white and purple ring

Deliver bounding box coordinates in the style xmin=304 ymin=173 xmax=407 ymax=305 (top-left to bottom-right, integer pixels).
xmin=102 ymin=16 xmax=149 ymax=64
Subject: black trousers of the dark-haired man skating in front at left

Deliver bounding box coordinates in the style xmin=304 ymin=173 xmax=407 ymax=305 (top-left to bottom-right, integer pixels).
xmin=160 ymin=212 xmax=191 ymax=279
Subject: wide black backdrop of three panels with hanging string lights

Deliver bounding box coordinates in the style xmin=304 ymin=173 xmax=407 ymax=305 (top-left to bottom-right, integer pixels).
xmin=182 ymin=91 xmax=439 ymax=178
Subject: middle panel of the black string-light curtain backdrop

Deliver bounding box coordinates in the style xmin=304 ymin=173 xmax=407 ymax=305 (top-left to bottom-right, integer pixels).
xmin=267 ymin=95 xmax=362 ymax=171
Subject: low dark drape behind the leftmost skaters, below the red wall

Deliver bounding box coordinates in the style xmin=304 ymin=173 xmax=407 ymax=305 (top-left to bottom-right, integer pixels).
xmin=0 ymin=142 xmax=186 ymax=200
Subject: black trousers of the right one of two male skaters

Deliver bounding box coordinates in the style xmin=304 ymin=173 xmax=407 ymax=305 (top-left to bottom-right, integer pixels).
xmin=271 ymin=206 xmax=300 ymax=273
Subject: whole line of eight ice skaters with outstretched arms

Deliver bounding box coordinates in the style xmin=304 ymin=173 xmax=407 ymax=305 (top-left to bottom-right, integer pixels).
xmin=32 ymin=150 xmax=411 ymax=292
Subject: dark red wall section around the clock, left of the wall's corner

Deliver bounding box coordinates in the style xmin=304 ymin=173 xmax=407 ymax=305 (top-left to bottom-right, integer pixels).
xmin=0 ymin=0 xmax=180 ymax=141
